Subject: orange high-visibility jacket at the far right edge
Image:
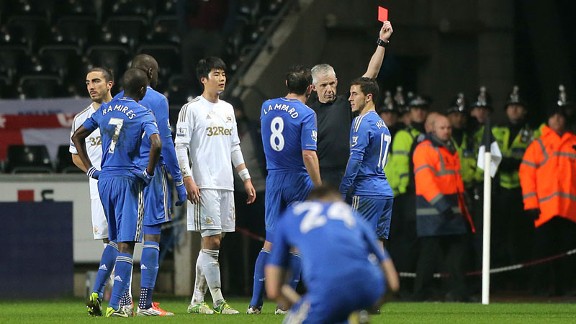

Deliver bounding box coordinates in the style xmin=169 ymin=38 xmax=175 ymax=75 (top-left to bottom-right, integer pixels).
xmin=520 ymin=126 xmax=576 ymax=227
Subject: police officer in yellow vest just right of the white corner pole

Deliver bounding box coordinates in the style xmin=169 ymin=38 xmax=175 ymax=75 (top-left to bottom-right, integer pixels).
xmin=492 ymin=86 xmax=539 ymax=288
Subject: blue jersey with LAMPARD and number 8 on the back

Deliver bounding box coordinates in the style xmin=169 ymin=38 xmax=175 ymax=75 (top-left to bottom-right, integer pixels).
xmin=260 ymin=98 xmax=317 ymax=171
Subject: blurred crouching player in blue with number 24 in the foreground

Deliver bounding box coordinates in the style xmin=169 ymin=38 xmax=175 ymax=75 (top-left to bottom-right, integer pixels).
xmin=266 ymin=186 xmax=399 ymax=323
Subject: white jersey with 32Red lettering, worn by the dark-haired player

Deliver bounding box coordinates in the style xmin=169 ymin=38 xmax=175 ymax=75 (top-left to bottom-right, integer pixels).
xmin=174 ymin=96 xmax=240 ymax=190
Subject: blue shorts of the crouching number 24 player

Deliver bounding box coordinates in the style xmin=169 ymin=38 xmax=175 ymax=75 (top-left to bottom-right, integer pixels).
xmin=284 ymin=266 xmax=385 ymax=323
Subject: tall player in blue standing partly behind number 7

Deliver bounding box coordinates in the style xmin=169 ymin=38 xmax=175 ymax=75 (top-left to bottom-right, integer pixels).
xmin=115 ymin=54 xmax=186 ymax=316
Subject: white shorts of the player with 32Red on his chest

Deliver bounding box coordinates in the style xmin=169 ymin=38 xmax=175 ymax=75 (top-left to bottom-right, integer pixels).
xmin=187 ymin=189 xmax=236 ymax=232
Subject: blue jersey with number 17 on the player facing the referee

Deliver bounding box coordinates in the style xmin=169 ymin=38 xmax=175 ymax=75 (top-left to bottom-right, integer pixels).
xmin=340 ymin=111 xmax=394 ymax=197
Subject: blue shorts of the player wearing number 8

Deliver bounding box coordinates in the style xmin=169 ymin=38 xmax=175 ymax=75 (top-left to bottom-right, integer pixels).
xmin=264 ymin=171 xmax=313 ymax=242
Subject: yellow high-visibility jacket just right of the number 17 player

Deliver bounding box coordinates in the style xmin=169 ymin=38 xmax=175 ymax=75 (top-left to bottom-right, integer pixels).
xmin=384 ymin=126 xmax=420 ymax=196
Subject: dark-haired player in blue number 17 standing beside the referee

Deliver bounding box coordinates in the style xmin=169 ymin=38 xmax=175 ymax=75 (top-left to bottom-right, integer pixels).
xmin=340 ymin=77 xmax=394 ymax=246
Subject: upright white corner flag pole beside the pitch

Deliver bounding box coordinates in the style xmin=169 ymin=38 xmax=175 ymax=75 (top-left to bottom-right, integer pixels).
xmin=482 ymin=117 xmax=492 ymax=305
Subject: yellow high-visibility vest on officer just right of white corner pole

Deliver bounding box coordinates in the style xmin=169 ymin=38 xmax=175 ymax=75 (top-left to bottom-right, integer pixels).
xmin=492 ymin=124 xmax=540 ymax=189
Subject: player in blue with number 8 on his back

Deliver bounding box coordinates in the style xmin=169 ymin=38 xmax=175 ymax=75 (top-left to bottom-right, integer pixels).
xmin=246 ymin=66 xmax=322 ymax=314
